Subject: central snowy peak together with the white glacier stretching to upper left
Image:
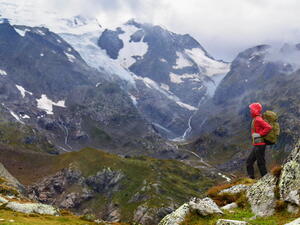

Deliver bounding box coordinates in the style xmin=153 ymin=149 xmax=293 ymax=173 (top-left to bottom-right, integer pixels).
xmin=0 ymin=0 xmax=230 ymax=139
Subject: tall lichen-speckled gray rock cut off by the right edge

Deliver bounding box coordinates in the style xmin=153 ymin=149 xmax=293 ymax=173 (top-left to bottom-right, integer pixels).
xmin=279 ymin=142 xmax=300 ymax=206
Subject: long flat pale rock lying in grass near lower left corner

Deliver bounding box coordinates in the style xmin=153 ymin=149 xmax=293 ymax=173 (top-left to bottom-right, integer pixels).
xmin=5 ymin=202 xmax=58 ymax=215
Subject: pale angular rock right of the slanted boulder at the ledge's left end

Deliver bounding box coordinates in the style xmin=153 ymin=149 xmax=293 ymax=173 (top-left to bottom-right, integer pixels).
xmin=189 ymin=198 xmax=223 ymax=216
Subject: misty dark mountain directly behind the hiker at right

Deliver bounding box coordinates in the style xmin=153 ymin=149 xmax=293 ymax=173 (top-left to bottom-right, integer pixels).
xmin=186 ymin=44 xmax=300 ymax=170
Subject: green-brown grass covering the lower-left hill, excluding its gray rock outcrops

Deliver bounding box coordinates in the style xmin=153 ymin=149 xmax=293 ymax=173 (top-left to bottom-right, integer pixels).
xmin=0 ymin=146 xmax=215 ymax=221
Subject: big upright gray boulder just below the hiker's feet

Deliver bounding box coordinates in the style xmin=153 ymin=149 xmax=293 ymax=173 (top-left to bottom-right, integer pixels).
xmin=246 ymin=174 xmax=278 ymax=216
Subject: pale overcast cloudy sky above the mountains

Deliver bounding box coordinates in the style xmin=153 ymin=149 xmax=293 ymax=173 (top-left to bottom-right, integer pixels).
xmin=43 ymin=0 xmax=300 ymax=61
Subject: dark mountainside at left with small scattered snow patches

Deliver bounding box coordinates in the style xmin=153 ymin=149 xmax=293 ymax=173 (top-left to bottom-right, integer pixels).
xmin=0 ymin=22 xmax=178 ymax=156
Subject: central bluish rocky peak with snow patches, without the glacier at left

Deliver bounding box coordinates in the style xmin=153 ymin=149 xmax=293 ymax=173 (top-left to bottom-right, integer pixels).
xmin=98 ymin=20 xmax=229 ymax=139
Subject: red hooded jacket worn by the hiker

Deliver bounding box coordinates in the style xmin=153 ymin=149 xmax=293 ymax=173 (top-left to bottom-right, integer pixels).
xmin=249 ymin=103 xmax=272 ymax=145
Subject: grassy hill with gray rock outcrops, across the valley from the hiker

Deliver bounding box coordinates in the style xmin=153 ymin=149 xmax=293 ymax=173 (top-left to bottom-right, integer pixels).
xmin=0 ymin=142 xmax=221 ymax=224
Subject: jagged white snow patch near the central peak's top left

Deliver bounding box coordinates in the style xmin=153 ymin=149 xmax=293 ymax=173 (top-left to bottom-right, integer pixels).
xmin=116 ymin=24 xmax=148 ymax=68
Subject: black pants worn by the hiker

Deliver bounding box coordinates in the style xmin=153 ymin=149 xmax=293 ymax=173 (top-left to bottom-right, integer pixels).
xmin=247 ymin=145 xmax=267 ymax=179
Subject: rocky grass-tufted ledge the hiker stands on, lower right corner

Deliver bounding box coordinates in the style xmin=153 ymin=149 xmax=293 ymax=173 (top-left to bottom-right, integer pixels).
xmin=159 ymin=138 xmax=300 ymax=225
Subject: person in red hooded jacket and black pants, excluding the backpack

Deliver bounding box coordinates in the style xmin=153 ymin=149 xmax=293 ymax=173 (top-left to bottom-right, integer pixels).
xmin=246 ymin=103 xmax=272 ymax=179
